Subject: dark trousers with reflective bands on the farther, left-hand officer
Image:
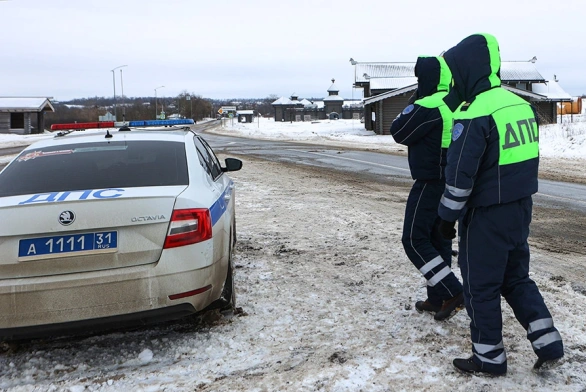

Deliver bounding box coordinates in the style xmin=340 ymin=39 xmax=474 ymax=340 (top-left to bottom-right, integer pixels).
xmin=402 ymin=180 xmax=462 ymax=305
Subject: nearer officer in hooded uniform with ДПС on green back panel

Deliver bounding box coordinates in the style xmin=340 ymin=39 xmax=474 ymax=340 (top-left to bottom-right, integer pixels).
xmin=438 ymin=34 xmax=564 ymax=375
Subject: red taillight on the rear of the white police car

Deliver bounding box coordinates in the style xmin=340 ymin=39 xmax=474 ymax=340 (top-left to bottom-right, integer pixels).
xmin=164 ymin=208 xmax=212 ymax=249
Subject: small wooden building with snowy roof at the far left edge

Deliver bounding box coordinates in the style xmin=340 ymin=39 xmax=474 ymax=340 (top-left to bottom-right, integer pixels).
xmin=0 ymin=97 xmax=55 ymax=135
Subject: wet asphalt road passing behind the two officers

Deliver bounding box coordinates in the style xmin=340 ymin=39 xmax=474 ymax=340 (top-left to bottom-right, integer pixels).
xmin=197 ymin=125 xmax=586 ymax=295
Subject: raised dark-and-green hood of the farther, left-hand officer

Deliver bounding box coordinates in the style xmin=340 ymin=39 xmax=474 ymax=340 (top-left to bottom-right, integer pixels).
xmin=415 ymin=56 xmax=452 ymax=98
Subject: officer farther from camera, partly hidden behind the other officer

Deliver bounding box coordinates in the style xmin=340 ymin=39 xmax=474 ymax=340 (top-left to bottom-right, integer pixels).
xmin=391 ymin=56 xmax=464 ymax=320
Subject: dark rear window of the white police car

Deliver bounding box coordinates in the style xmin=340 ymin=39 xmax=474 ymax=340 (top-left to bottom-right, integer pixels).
xmin=0 ymin=141 xmax=188 ymax=197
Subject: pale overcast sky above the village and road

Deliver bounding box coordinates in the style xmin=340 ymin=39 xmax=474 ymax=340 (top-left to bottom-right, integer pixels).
xmin=0 ymin=0 xmax=586 ymax=100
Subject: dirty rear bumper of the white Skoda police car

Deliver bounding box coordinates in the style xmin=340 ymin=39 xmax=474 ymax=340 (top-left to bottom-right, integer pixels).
xmin=0 ymin=264 xmax=225 ymax=339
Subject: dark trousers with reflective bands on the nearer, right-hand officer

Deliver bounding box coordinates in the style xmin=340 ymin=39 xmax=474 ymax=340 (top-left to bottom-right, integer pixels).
xmin=459 ymin=197 xmax=564 ymax=372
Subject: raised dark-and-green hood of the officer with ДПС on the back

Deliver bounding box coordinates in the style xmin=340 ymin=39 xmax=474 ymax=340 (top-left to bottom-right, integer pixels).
xmin=444 ymin=34 xmax=501 ymax=111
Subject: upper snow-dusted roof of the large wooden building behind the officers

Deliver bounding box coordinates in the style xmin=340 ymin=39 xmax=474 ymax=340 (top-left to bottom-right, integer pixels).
xmin=355 ymin=61 xmax=545 ymax=84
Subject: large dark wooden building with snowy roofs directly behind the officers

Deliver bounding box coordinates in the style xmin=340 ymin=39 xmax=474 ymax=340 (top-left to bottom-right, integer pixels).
xmin=352 ymin=58 xmax=572 ymax=135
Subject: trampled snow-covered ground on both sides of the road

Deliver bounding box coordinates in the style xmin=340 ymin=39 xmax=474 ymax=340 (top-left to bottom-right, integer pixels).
xmin=0 ymin=112 xmax=586 ymax=392
